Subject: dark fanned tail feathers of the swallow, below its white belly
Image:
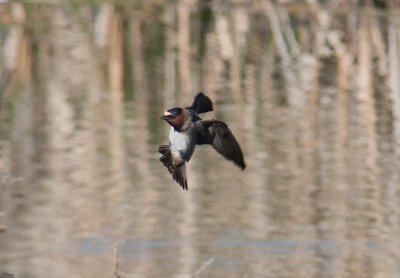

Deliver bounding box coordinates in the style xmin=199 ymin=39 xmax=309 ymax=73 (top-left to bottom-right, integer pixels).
xmin=158 ymin=145 xmax=188 ymax=190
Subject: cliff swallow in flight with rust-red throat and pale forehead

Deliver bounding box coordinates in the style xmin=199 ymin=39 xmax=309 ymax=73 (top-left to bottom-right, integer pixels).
xmin=158 ymin=93 xmax=246 ymax=190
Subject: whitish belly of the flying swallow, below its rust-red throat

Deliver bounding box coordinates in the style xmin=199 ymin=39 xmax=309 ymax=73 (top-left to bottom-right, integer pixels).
xmin=169 ymin=128 xmax=196 ymax=161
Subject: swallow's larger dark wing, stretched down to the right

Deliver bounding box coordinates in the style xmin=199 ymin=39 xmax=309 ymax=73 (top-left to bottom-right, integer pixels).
xmin=197 ymin=120 xmax=246 ymax=169
